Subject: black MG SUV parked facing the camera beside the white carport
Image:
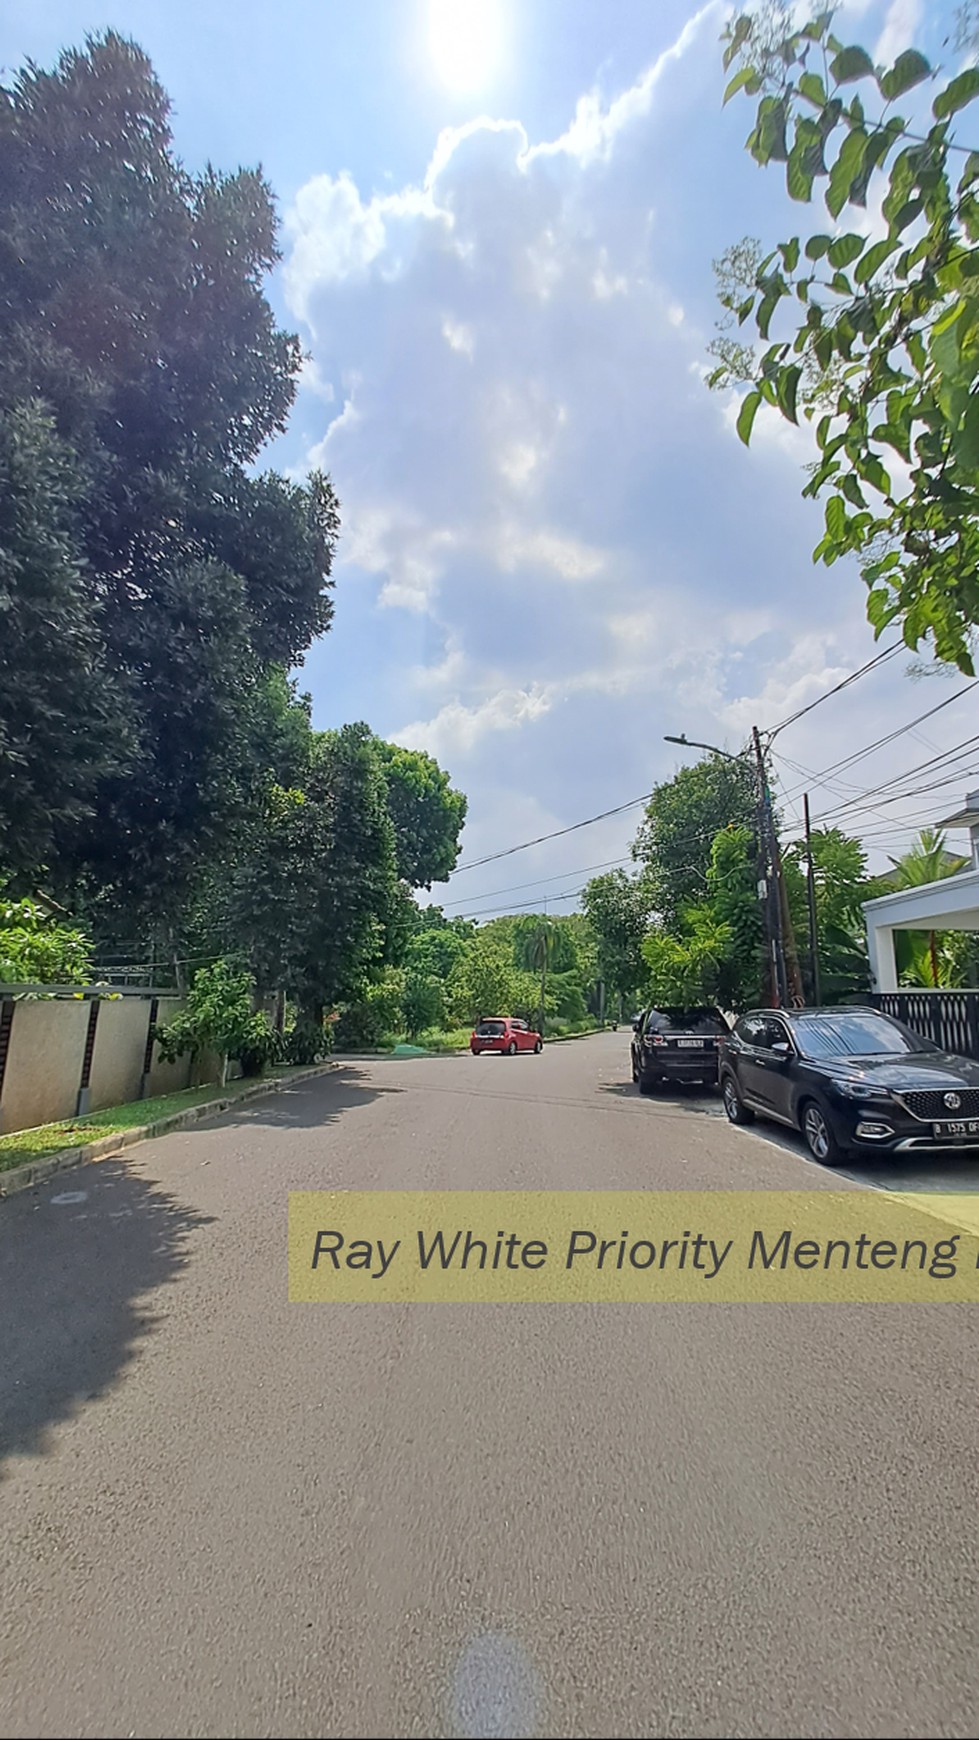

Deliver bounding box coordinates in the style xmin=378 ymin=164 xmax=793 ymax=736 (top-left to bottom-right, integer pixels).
xmin=720 ymin=1007 xmax=979 ymax=1166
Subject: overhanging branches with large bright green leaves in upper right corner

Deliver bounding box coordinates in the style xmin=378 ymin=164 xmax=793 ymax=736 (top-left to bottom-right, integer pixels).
xmin=711 ymin=0 xmax=979 ymax=673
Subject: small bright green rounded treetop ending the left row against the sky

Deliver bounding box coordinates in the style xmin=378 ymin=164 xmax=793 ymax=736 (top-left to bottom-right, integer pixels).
xmin=379 ymin=743 xmax=466 ymax=889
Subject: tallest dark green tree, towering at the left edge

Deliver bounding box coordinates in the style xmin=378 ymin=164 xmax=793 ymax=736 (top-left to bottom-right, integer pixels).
xmin=0 ymin=31 xmax=339 ymax=924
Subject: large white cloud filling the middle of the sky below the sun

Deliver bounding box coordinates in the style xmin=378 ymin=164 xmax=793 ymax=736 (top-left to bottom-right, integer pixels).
xmin=283 ymin=7 xmax=932 ymax=893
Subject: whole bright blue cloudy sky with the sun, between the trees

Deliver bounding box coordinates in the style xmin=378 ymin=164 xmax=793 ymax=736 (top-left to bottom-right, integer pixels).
xmin=0 ymin=0 xmax=979 ymax=915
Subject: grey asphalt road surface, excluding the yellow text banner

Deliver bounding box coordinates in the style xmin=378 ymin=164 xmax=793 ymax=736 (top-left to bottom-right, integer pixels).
xmin=0 ymin=1032 xmax=979 ymax=1737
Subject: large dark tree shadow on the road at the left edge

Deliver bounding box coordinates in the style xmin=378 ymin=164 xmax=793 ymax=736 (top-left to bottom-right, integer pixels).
xmin=0 ymin=1161 xmax=212 ymax=1460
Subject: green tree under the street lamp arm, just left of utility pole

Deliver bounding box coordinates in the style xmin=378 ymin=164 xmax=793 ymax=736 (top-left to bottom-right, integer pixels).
xmin=633 ymin=753 xmax=756 ymax=929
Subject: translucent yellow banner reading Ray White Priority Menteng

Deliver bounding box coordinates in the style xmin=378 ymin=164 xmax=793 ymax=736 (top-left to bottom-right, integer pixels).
xmin=289 ymin=1190 xmax=979 ymax=1305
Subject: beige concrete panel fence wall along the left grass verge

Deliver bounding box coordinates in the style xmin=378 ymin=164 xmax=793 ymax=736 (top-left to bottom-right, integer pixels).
xmin=0 ymin=992 xmax=191 ymax=1134
